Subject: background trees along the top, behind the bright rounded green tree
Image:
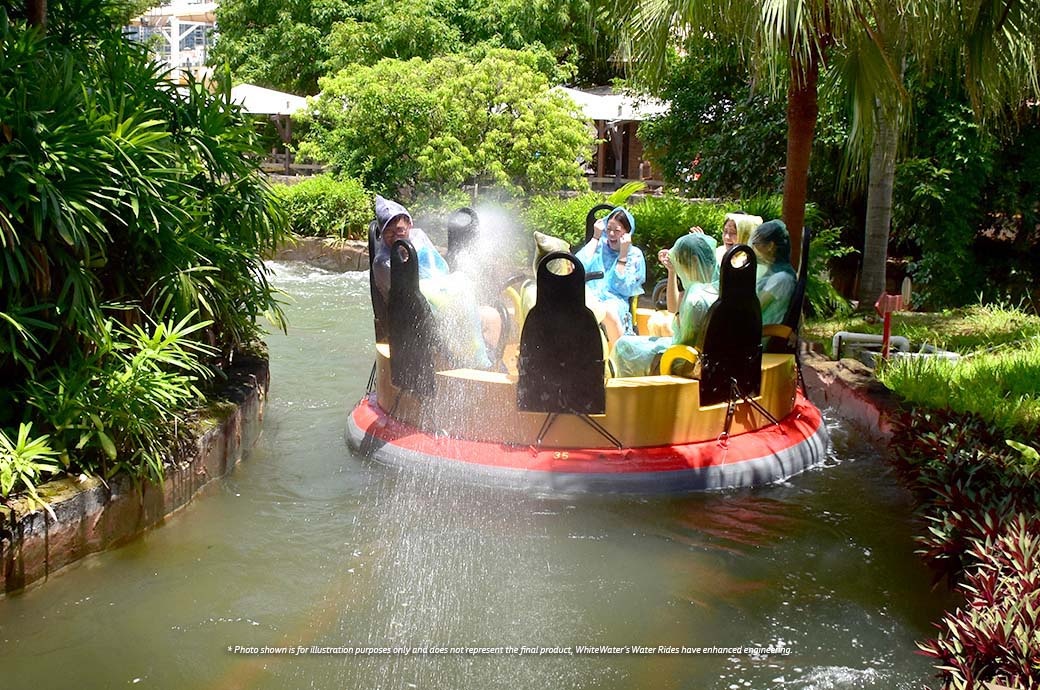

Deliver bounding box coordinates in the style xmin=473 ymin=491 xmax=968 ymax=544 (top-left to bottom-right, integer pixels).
xmin=210 ymin=0 xmax=619 ymax=95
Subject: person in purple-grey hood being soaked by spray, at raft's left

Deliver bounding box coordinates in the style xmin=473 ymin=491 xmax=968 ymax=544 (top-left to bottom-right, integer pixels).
xmin=372 ymin=195 xmax=502 ymax=368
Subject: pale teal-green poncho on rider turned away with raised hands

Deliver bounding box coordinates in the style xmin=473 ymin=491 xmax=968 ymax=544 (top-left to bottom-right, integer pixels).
xmin=613 ymin=233 xmax=719 ymax=376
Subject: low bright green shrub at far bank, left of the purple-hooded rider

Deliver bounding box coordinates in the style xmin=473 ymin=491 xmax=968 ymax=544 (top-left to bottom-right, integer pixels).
xmin=275 ymin=175 xmax=372 ymax=239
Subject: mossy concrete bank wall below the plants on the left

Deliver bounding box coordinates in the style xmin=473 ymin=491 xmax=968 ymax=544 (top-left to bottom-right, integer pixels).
xmin=0 ymin=355 xmax=269 ymax=596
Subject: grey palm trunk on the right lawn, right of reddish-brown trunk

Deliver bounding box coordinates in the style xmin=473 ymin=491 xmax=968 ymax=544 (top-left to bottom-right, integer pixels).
xmin=859 ymin=108 xmax=899 ymax=309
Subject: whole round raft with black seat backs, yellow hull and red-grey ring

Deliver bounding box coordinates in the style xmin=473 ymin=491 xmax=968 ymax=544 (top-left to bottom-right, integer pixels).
xmin=347 ymin=228 xmax=829 ymax=493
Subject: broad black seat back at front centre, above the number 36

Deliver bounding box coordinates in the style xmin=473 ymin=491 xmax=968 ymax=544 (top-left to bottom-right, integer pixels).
xmin=517 ymin=252 xmax=606 ymax=414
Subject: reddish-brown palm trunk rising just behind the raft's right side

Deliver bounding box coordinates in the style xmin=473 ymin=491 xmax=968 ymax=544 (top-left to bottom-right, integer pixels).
xmin=783 ymin=55 xmax=820 ymax=265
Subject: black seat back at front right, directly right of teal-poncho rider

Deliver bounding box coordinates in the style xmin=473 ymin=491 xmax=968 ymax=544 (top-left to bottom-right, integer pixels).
xmin=700 ymin=245 xmax=762 ymax=407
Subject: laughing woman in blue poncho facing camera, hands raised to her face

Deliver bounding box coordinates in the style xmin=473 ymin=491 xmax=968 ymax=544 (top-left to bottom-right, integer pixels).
xmin=574 ymin=206 xmax=647 ymax=334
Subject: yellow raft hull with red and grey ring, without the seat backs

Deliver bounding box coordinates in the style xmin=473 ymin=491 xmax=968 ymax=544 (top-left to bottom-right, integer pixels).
xmin=347 ymin=344 xmax=829 ymax=493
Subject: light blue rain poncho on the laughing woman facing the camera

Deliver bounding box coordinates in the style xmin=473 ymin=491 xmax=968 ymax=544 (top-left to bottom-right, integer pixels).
xmin=574 ymin=206 xmax=647 ymax=333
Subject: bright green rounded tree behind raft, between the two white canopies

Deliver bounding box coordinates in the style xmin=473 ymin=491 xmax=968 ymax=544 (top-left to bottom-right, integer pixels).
xmin=301 ymin=50 xmax=592 ymax=191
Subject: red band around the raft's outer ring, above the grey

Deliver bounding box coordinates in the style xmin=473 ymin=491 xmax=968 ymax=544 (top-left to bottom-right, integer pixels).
xmin=350 ymin=393 xmax=826 ymax=481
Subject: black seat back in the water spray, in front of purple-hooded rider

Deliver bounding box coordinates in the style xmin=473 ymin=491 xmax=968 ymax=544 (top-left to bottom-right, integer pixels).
xmin=387 ymin=239 xmax=437 ymax=395
